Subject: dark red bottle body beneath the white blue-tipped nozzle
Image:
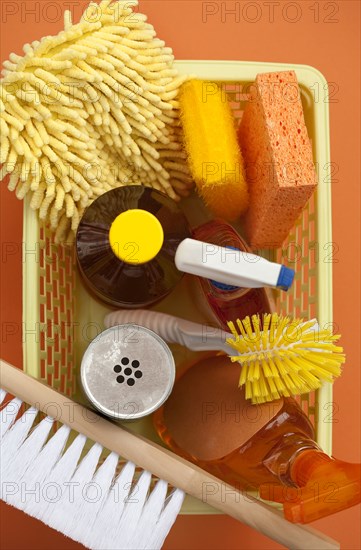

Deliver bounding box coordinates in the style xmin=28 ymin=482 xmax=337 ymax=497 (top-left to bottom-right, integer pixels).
xmin=192 ymin=219 xmax=276 ymax=330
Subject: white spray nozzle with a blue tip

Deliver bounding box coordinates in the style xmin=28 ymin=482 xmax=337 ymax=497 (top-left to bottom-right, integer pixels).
xmin=175 ymin=239 xmax=295 ymax=290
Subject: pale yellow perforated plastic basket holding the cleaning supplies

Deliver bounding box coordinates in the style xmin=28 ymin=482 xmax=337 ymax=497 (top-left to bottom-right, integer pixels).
xmin=23 ymin=61 xmax=333 ymax=513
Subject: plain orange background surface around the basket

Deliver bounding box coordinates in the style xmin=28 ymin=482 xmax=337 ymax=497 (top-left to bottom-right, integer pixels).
xmin=0 ymin=0 xmax=361 ymax=550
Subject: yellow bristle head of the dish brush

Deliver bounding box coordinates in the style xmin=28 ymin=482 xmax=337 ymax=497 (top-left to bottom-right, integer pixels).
xmin=227 ymin=313 xmax=345 ymax=403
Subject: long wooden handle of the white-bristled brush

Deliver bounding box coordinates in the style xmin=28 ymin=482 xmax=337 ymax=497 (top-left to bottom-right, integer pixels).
xmin=0 ymin=360 xmax=340 ymax=550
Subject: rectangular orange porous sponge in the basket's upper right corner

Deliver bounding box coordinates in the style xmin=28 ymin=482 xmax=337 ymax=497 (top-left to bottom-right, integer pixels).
xmin=238 ymin=71 xmax=317 ymax=248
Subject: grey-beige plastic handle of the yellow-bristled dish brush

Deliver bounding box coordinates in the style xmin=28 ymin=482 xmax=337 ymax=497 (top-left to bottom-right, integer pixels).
xmin=104 ymin=309 xmax=231 ymax=355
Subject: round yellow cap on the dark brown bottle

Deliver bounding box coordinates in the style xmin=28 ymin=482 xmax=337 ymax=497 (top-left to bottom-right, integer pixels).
xmin=109 ymin=208 xmax=164 ymax=265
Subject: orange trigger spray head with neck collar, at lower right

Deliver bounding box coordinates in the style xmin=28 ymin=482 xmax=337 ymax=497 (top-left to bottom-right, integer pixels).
xmin=260 ymin=434 xmax=361 ymax=523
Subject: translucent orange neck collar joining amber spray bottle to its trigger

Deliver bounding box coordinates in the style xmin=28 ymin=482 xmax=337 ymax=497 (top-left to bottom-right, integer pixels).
xmin=263 ymin=433 xmax=320 ymax=487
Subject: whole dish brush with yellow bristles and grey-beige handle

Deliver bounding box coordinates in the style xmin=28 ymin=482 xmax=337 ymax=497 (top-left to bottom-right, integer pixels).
xmin=104 ymin=310 xmax=345 ymax=403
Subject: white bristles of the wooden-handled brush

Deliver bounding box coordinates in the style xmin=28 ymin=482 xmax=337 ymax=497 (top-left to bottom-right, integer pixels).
xmin=0 ymin=389 xmax=184 ymax=550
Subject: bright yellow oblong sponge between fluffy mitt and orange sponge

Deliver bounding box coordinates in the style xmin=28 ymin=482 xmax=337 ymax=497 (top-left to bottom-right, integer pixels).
xmin=179 ymin=80 xmax=248 ymax=220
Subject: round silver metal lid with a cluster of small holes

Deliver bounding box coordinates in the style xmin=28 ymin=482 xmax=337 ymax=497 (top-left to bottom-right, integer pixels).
xmin=81 ymin=324 xmax=175 ymax=420
